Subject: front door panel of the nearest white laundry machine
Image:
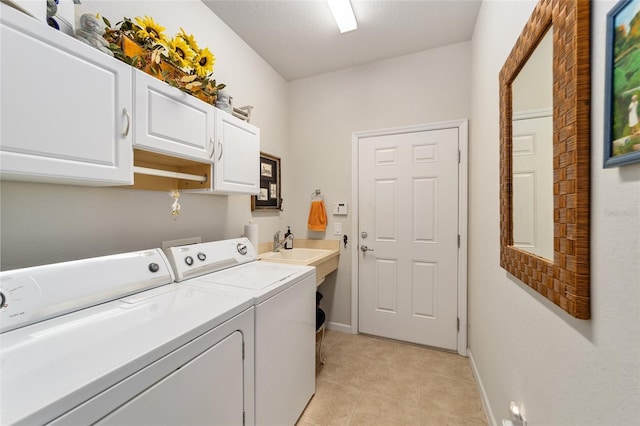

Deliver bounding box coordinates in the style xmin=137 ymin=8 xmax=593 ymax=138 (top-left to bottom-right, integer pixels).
xmin=96 ymin=331 xmax=243 ymax=426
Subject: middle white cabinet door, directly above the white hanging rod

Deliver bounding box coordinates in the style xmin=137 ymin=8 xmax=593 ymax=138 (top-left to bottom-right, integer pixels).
xmin=133 ymin=70 xmax=215 ymax=162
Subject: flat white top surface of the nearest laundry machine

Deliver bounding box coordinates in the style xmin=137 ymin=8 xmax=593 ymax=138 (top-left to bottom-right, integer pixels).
xmin=0 ymin=284 xmax=252 ymax=424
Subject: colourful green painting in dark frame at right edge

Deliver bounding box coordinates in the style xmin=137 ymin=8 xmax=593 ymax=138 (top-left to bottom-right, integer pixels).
xmin=604 ymin=0 xmax=640 ymax=167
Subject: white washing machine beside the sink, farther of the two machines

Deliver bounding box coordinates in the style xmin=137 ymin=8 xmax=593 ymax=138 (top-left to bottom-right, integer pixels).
xmin=166 ymin=238 xmax=316 ymax=426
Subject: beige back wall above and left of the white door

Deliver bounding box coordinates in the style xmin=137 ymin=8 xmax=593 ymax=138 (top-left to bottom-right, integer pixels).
xmin=285 ymin=42 xmax=471 ymax=330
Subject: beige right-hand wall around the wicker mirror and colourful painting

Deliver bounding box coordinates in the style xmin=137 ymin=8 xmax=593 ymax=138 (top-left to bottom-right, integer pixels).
xmin=469 ymin=0 xmax=640 ymax=425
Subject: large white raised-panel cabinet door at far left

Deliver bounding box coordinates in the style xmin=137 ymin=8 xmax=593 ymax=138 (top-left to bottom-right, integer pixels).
xmin=0 ymin=3 xmax=133 ymax=185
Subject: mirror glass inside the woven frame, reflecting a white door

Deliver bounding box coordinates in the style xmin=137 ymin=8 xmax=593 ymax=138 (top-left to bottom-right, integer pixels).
xmin=511 ymin=28 xmax=553 ymax=260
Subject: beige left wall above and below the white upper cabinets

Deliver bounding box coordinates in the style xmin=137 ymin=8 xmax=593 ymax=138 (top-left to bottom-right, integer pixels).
xmin=0 ymin=0 xmax=289 ymax=270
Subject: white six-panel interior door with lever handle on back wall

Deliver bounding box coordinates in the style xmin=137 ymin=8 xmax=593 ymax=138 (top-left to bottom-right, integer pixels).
xmin=358 ymin=128 xmax=459 ymax=350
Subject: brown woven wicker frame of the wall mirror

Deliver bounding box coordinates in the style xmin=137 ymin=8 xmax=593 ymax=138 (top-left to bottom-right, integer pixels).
xmin=500 ymin=0 xmax=591 ymax=319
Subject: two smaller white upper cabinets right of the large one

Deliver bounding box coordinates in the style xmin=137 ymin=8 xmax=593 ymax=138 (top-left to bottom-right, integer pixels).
xmin=133 ymin=70 xmax=260 ymax=194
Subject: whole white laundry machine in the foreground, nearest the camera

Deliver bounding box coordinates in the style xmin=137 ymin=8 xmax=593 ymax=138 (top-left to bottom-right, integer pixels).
xmin=0 ymin=249 xmax=254 ymax=426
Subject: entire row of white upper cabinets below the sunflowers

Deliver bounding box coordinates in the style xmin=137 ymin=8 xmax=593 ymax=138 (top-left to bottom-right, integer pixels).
xmin=0 ymin=3 xmax=260 ymax=194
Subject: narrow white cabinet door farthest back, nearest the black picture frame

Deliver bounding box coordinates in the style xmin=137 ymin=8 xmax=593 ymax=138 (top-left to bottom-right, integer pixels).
xmin=213 ymin=109 xmax=260 ymax=194
